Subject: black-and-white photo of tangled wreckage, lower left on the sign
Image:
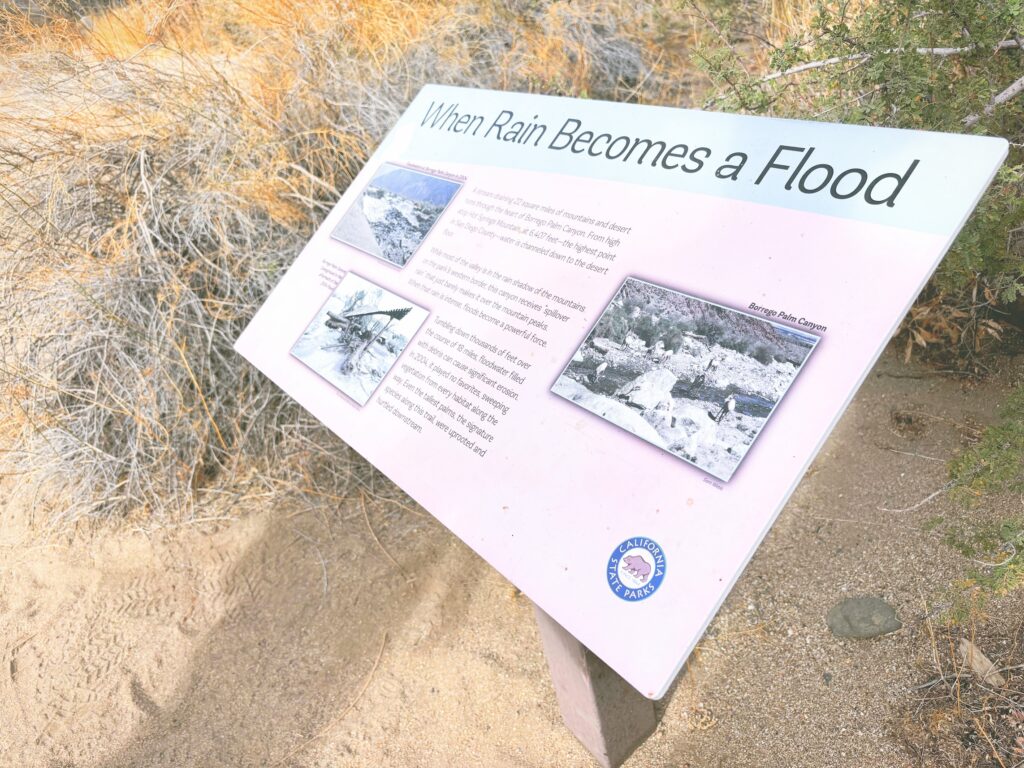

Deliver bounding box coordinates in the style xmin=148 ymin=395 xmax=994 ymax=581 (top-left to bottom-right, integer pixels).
xmin=292 ymin=272 xmax=428 ymax=406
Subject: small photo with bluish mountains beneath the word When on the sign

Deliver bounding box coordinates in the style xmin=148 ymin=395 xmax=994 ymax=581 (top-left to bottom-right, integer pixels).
xmin=331 ymin=163 xmax=462 ymax=267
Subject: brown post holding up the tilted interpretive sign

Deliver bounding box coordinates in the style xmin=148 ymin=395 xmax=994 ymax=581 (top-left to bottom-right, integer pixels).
xmin=534 ymin=605 xmax=657 ymax=768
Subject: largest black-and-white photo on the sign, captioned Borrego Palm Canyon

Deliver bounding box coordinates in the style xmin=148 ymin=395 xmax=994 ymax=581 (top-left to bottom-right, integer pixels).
xmin=551 ymin=278 xmax=818 ymax=481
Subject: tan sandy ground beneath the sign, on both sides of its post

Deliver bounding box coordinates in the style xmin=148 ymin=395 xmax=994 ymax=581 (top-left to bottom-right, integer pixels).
xmin=0 ymin=355 xmax=1019 ymax=768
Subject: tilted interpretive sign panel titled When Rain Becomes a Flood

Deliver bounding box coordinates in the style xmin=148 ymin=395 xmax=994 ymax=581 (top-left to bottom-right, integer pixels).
xmin=237 ymin=86 xmax=1007 ymax=698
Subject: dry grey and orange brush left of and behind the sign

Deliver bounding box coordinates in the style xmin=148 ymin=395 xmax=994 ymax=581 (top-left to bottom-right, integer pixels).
xmin=0 ymin=0 xmax=693 ymax=523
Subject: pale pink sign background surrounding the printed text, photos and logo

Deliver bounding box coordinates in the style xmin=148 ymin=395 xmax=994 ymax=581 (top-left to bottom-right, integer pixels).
xmin=237 ymin=87 xmax=1005 ymax=698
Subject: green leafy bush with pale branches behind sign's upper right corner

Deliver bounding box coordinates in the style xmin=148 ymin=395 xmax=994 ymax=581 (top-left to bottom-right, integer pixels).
xmin=694 ymin=0 xmax=1024 ymax=359
